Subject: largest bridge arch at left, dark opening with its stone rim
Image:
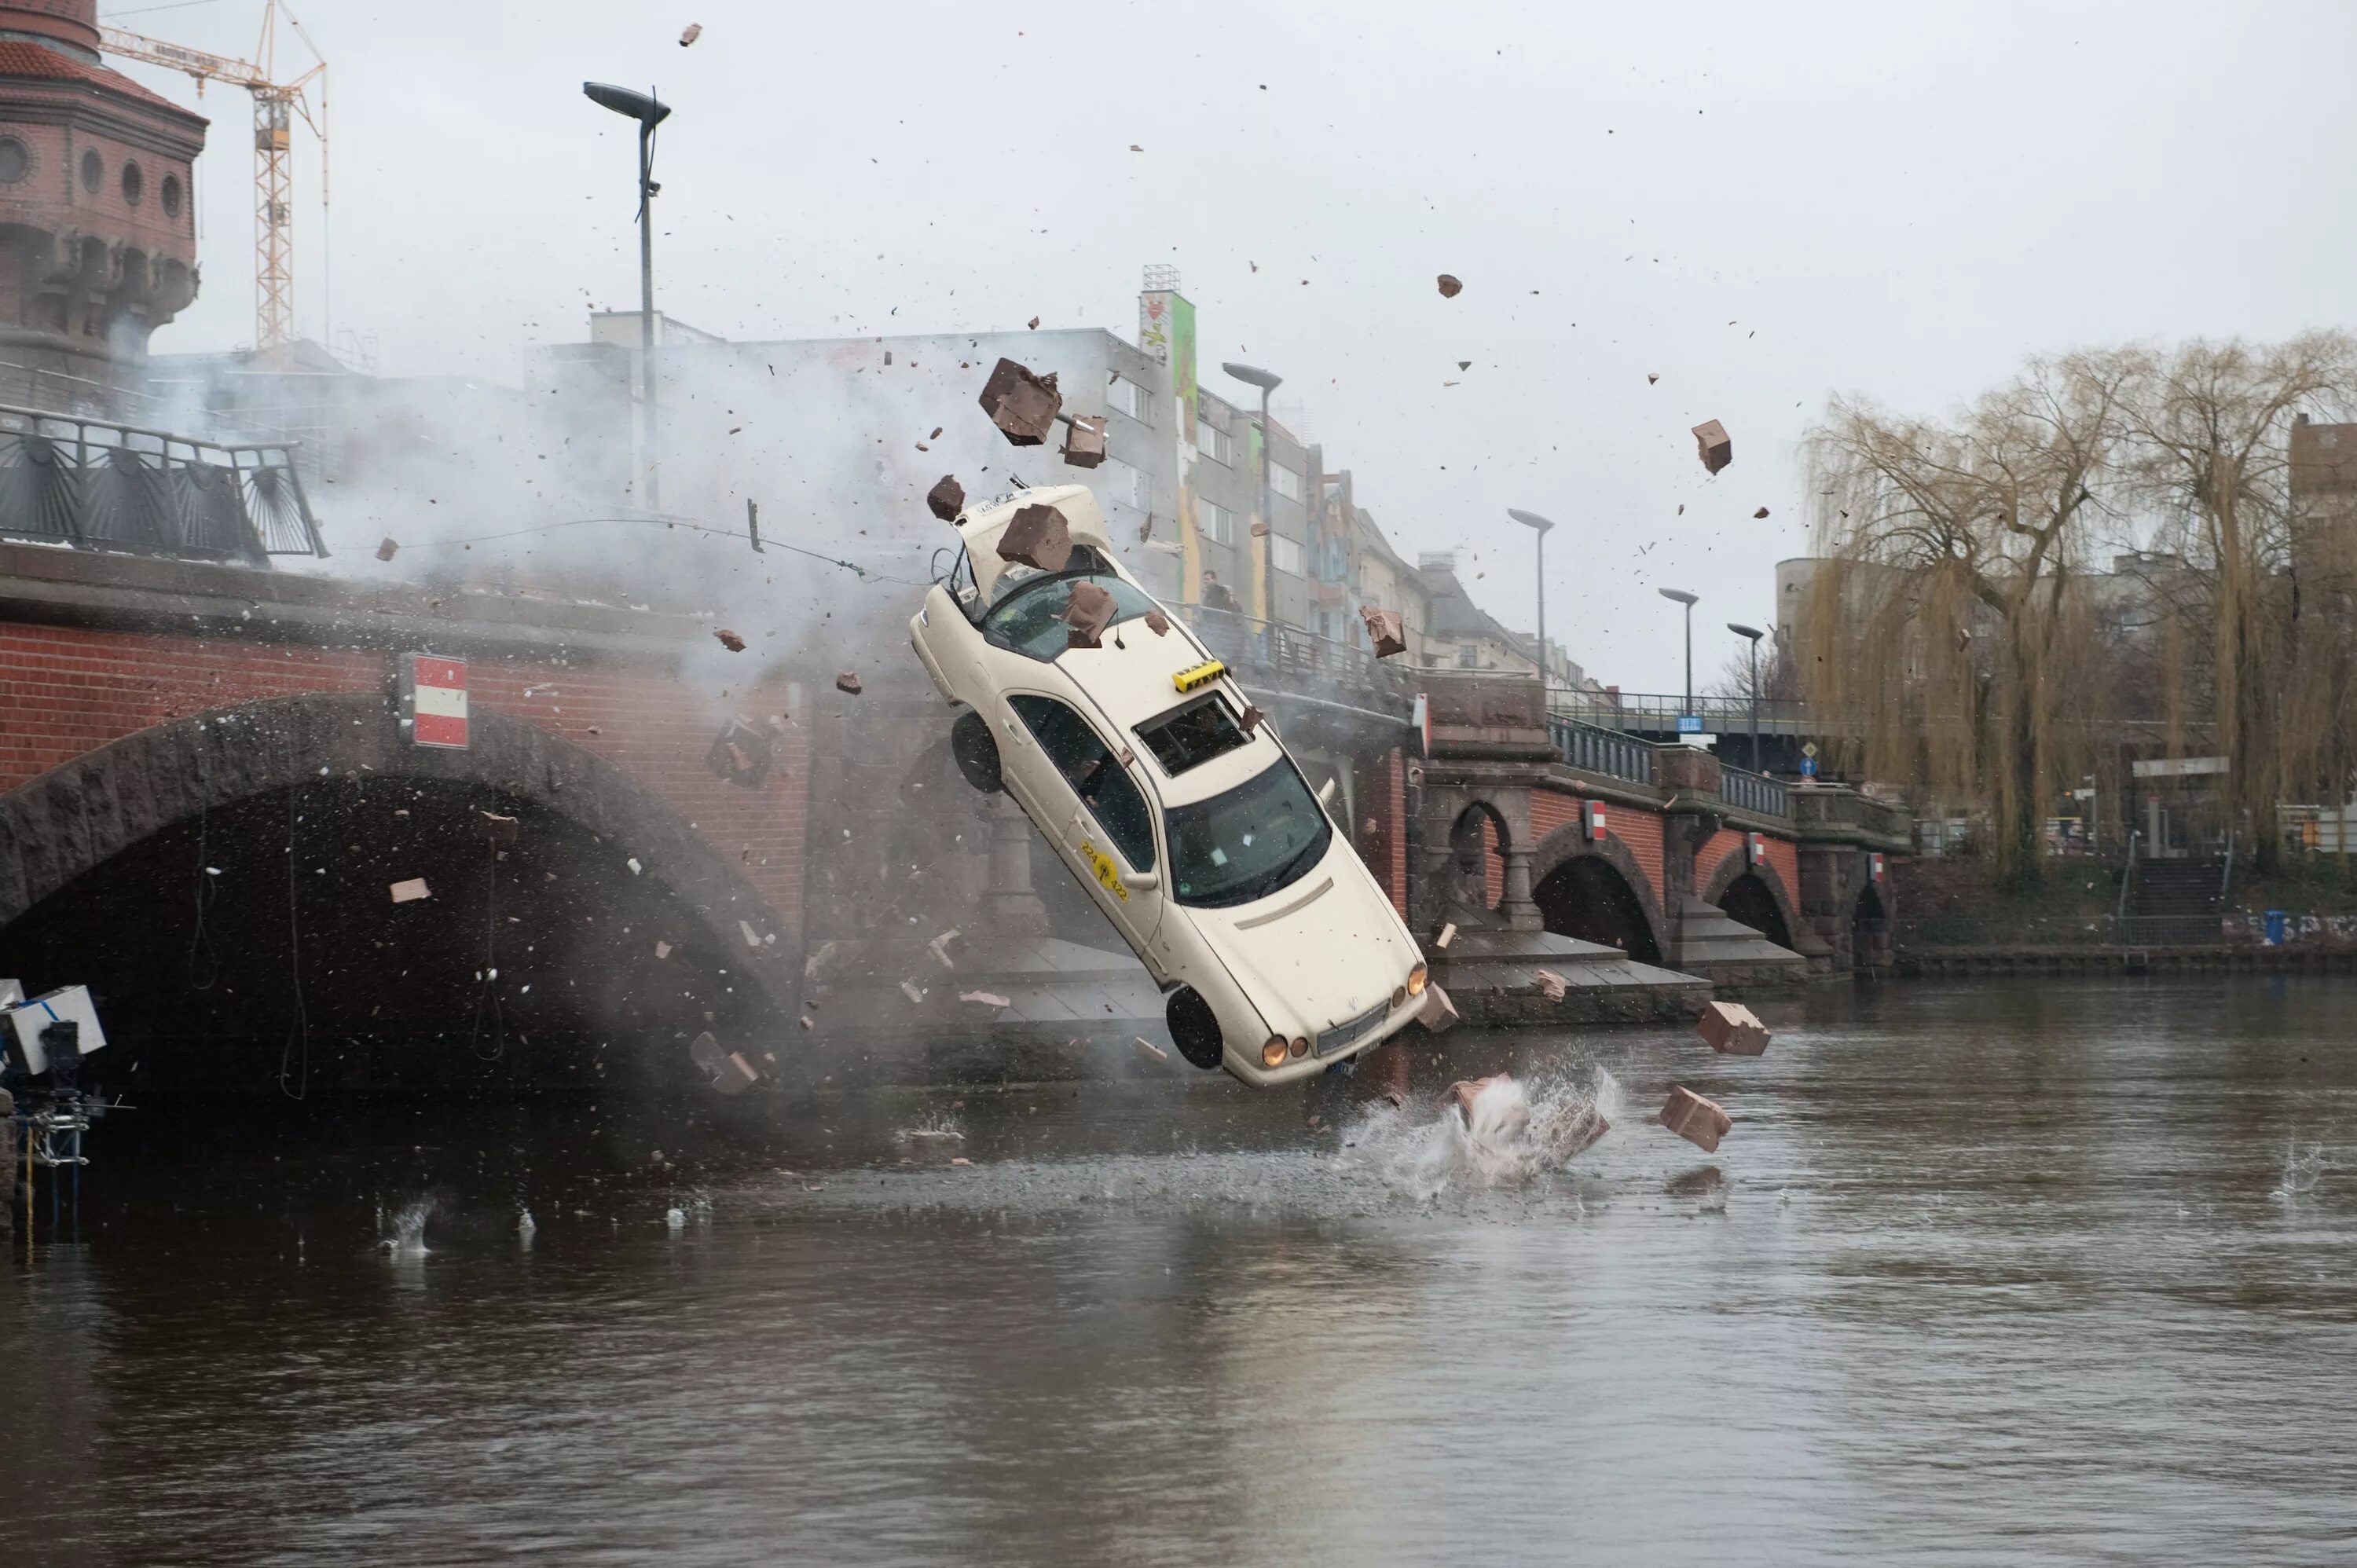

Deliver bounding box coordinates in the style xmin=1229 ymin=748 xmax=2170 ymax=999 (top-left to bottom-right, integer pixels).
xmin=0 ymin=698 xmax=792 ymax=1101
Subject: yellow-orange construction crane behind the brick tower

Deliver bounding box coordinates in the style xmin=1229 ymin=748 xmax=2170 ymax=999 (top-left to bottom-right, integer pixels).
xmin=99 ymin=0 xmax=328 ymax=349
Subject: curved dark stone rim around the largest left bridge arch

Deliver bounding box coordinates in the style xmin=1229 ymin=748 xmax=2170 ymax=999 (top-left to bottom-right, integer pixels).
xmin=0 ymin=693 xmax=799 ymax=1012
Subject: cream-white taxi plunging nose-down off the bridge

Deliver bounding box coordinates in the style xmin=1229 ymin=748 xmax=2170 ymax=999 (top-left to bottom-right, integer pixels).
xmin=907 ymin=485 xmax=1424 ymax=1085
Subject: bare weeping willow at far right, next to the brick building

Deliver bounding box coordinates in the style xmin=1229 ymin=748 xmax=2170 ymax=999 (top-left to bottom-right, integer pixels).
xmin=2124 ymin=332 xmax=2357 ymax=866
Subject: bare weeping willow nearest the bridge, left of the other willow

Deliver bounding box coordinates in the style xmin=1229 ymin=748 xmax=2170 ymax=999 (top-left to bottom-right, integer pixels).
xmin=1798 ymin=354 xmax=2138 ymax=880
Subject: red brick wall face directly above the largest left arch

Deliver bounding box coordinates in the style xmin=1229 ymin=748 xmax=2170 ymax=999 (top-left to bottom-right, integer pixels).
xmin=0 ymin=622 xmax=811 ymax=943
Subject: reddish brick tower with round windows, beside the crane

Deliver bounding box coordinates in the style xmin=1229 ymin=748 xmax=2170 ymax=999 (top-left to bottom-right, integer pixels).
xmin=0 ymin=0 xmax=205 ymax=419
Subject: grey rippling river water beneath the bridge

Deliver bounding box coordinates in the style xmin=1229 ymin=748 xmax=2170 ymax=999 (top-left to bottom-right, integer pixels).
xmin=0 ymin=979 xmax=2357 ymax=1568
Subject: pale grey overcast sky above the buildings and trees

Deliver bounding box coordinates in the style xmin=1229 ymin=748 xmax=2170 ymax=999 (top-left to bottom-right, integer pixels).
xmin=104 ymin=0 xmax=2357 ymax=691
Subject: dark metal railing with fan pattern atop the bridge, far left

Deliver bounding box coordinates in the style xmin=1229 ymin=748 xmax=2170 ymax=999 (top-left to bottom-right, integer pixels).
xmin=0 ymin=405 xmax=328 ymax=563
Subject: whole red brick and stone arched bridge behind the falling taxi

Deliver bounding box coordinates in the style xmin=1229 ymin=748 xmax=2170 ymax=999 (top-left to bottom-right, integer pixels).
xmin=0 ymin=544 xmax=1904 ymax=1094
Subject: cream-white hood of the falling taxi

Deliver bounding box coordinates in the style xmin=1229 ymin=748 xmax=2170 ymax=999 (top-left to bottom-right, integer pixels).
xmin=1188 ymin=833 xmax=1424 ymax=1040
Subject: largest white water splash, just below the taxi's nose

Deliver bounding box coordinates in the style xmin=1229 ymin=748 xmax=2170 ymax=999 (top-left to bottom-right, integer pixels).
xmin=1341 ymin=1066 xmax=1622 ymax=1203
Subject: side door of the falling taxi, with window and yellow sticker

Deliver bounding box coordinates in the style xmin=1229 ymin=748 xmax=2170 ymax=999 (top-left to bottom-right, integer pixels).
xmin=1002 ymin=693 xmax=1162 ymax=952
